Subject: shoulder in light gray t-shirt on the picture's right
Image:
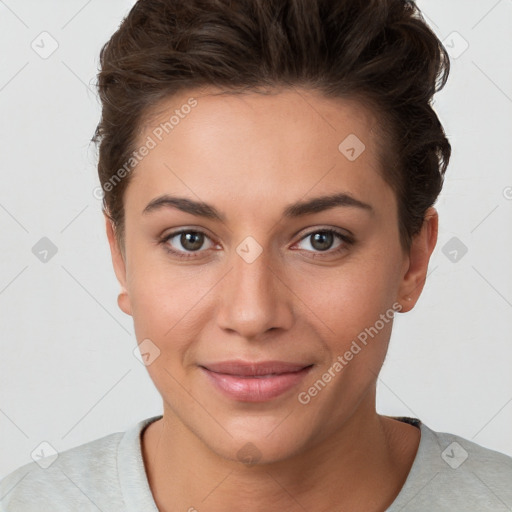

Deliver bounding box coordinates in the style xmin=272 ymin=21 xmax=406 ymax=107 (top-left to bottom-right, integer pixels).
xmin=388 ymin=422 xmax=512 ymax=512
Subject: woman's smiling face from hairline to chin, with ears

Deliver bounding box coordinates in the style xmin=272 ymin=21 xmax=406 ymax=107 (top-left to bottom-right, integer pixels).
xmin=107 ymin=91 xmax=435 ymax=461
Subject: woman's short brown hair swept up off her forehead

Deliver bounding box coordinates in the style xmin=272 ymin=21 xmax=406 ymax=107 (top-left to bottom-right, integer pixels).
xmin=92 ymin=0 xmax=451 ymax=254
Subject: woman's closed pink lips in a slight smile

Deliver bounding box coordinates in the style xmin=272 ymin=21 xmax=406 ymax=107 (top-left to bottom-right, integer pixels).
xmin=200 ymin=361 xmax=313 ymax=402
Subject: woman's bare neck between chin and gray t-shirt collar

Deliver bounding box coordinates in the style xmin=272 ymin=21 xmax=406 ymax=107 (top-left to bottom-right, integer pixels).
xmin=142 ymin=393 xmax=420 ymax=512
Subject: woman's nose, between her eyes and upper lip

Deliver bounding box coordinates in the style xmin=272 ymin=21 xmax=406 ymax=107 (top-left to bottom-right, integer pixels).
xmin=217 ymin=244 xmax=293 ymax=340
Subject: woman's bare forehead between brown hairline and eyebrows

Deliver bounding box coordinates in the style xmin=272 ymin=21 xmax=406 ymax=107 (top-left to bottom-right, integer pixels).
xmin=127 ymin=85 xmax=392 ymax=216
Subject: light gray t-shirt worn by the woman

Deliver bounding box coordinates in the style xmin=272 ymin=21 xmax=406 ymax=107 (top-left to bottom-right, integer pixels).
xmin=0 ymin=416 xmax=512 ymax=512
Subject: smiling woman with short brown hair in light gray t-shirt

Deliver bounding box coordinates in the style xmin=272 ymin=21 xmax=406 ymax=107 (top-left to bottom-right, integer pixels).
xmin=2 ymin=0 xmax=512 ymax=512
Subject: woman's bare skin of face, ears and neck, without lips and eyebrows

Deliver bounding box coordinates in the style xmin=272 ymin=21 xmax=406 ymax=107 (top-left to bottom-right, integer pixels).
xmin=106 ymin=90 xmax=438 ymax=512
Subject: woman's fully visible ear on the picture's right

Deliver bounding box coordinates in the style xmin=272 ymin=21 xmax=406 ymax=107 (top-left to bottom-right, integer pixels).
xmin=398 ymin=207 xmax=439 ymax=313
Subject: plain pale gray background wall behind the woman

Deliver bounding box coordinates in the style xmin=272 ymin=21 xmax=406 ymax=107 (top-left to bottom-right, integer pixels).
xmin=0 ymin=0 xmax=512 ymax=477
